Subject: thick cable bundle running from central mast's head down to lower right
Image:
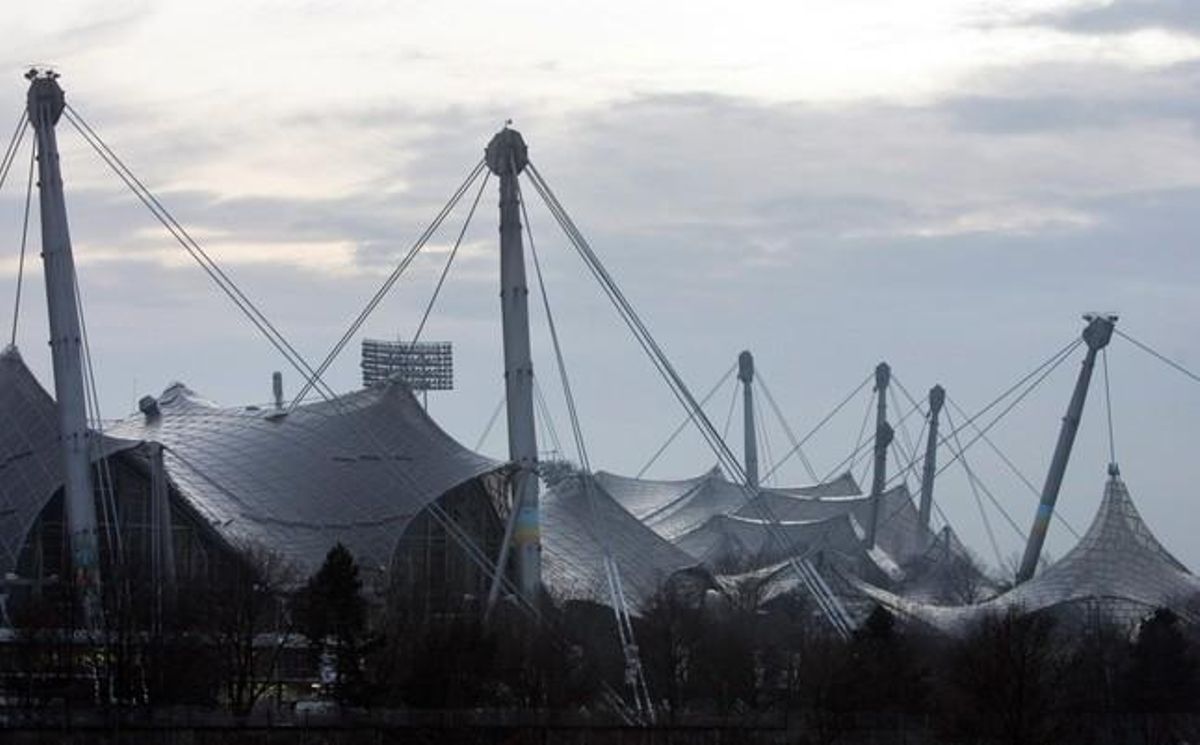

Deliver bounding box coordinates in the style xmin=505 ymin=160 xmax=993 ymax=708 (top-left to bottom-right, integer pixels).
xmin=526 ymin=163 xmax=852 ymax=638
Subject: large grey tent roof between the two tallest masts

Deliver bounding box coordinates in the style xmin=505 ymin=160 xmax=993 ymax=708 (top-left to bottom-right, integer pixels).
xmin=99 ymin=374 xmax=502 ymax=572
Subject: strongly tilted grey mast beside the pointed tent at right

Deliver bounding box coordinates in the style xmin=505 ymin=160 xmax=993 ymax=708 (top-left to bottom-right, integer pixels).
xmin=1016 ymin=313 xmax=1117 ymax=584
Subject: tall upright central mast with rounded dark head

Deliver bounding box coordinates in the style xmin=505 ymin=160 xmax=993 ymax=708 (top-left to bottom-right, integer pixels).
xmin=485 ymin=126 xmax=541 ymax=601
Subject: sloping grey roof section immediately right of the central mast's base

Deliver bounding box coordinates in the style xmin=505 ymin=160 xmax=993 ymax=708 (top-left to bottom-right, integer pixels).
xmin=541 ymin=474 xmax=696 ymax=612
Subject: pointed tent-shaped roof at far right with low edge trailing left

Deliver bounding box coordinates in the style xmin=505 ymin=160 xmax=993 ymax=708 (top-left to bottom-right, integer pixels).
xmin=854 ymin=475 xmax=1200 ymax=632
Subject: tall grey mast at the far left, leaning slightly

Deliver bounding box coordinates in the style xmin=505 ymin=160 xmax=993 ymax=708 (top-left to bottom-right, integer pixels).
xmin=25 ymin=68 xmax=101 ymax=629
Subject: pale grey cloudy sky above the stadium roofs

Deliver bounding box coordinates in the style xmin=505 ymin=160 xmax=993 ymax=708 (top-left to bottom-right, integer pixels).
xmin=0 ymin=0 xmax=1200 ymax=567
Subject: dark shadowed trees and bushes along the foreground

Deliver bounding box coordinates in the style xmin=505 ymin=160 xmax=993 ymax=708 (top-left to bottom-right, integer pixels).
xmin=4 ymin=539 xmax=1200 ymax=745
